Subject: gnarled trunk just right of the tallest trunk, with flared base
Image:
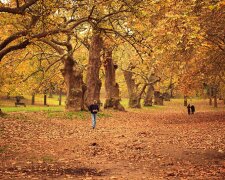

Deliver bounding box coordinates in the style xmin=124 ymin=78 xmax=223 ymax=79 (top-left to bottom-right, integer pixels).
xmin=104 ymin=49 xmax=125 ymax=111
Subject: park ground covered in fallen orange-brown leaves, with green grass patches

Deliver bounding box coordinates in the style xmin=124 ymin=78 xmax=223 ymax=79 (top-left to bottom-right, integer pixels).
xmin=0 ymin=100 xmax=225 ymax=180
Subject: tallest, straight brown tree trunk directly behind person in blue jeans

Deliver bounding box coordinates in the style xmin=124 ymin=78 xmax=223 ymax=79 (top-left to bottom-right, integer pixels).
xmin=86 ymin=33 xmax=102 ymax=106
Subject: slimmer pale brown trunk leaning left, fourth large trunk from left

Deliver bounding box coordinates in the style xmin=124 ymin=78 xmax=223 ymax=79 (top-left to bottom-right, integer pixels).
xmin=123 ymin=71 xmax=141 ymax=108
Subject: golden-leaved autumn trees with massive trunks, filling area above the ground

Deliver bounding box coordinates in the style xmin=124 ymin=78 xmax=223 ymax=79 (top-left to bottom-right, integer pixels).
xmin=0 ymin=0 xmax=225 ymax=111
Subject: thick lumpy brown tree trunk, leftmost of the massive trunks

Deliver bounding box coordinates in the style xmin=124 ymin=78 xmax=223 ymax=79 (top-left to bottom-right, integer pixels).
xmin=62 ymin=55 xmax=84 ymax=111
